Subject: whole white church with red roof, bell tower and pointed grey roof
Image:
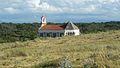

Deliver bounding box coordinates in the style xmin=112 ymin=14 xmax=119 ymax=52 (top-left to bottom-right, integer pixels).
xmin=38 ymin=16 xmax=80 ymax=37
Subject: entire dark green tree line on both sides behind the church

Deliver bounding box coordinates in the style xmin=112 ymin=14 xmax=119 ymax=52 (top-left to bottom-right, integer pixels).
xmin=0 ymin=21 xmax=120 ymax=43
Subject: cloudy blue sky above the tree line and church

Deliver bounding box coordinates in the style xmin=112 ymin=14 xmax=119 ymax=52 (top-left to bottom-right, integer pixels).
xmin=0 ymin=0 xmax=120 ymax=23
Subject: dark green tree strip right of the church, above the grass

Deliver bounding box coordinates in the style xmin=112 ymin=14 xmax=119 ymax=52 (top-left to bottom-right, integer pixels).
xmin=76 ymin=21 xmax=120 ymax=33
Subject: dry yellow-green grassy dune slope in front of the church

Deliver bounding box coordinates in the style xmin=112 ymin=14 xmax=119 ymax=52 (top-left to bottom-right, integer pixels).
xmin=0 ymin=30 xmax=120 ymax=68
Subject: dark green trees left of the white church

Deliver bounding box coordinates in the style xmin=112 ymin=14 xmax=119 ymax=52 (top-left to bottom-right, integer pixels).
xmin=0 ymin=23 xmax=40 ymax=43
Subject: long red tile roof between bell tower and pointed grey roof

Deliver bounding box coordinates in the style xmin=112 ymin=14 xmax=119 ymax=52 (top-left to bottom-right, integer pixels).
xmin=41 ymin=24 xmax=65 ymax=30
